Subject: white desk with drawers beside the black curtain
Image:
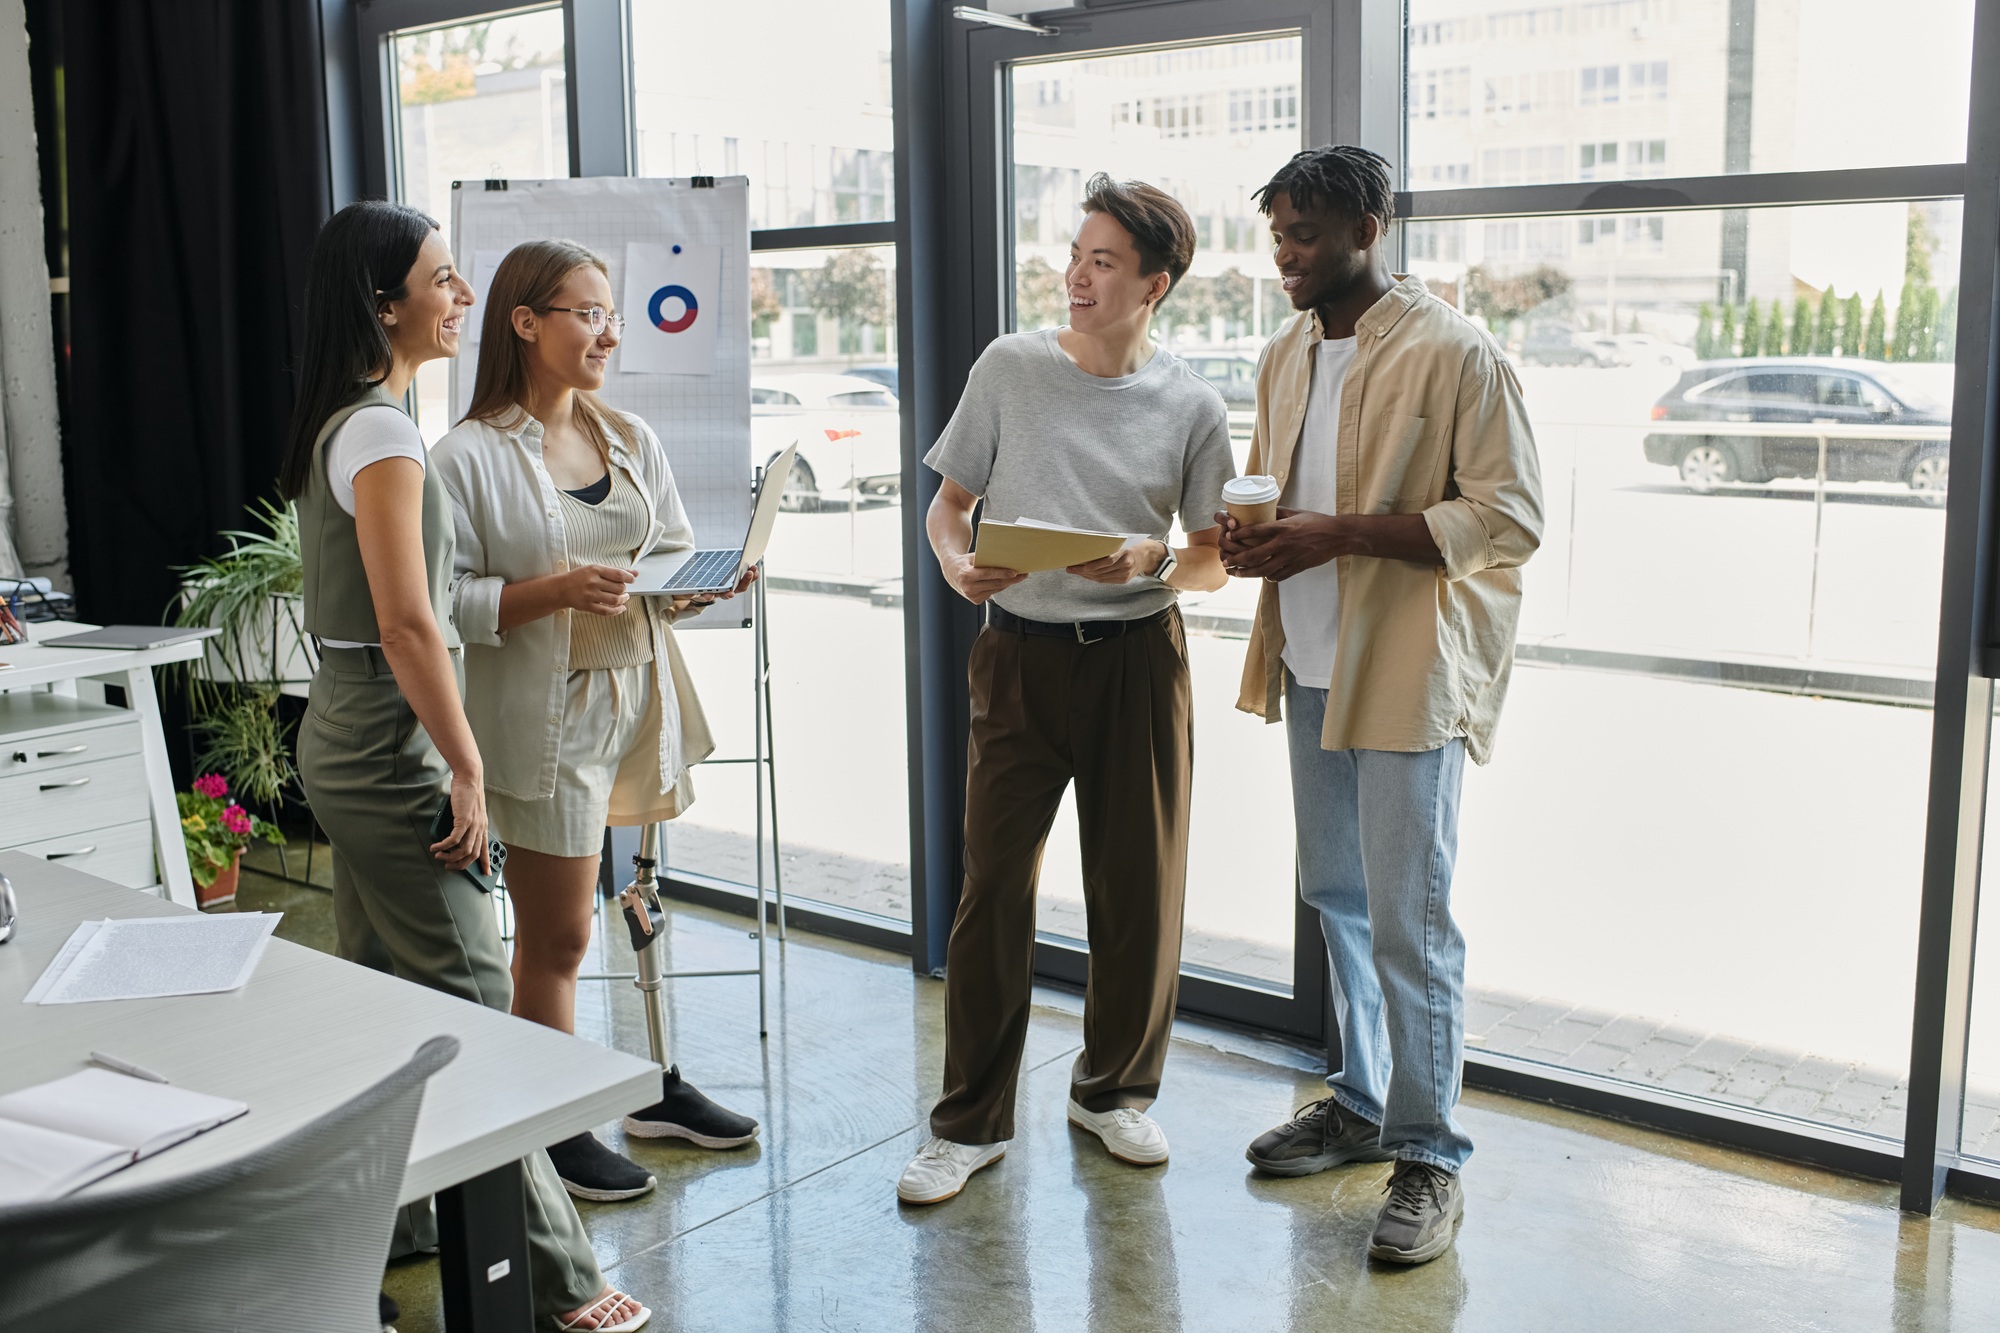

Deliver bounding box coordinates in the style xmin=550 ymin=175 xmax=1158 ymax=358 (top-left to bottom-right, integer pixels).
xmin=0 ymin=620 xmax=204 ymax=907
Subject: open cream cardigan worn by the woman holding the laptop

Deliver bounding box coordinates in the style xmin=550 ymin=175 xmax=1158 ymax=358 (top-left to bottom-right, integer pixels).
xmin=430 ymin=412 xmax=716 ymax=813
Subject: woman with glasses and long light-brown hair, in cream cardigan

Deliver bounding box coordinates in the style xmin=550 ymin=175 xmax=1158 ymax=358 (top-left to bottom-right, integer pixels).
xmin=436 ymin=240 xmax=758 ymax=1201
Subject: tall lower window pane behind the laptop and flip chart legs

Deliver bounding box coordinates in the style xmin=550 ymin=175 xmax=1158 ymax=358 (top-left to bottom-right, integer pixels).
xmin=668 ymin=246 xmax=910 ymax=921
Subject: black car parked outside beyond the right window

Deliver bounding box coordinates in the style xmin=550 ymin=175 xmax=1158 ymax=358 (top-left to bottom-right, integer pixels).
xmin=1646 ymin=356 xmax=1952 ymax=500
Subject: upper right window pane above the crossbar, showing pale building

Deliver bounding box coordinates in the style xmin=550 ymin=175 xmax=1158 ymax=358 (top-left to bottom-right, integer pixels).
xmin=1408 ymin=0 xmax=1972 ymax=190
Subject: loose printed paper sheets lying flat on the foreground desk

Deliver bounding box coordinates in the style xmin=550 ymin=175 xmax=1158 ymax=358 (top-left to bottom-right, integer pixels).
xmin=22 ymin=913 xmax=280 ymax=1005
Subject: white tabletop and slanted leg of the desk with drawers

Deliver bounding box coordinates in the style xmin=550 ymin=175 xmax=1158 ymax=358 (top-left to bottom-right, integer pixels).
xmin=0 ymin=620 xmax=202 ymax=907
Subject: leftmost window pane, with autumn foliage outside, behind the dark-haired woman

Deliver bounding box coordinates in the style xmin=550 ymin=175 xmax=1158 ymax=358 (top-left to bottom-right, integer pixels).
xmin=394 ymin=6 xmax=570 ymax=442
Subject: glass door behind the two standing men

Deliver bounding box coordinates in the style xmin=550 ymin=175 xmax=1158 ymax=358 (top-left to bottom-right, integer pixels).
xmin=970 ymin=2 xmax=1330 ymax=1035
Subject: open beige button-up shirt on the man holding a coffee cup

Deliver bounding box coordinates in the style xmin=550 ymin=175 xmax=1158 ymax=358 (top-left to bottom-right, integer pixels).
xmin=1236 ymin=278 xmax=1542 ymax=763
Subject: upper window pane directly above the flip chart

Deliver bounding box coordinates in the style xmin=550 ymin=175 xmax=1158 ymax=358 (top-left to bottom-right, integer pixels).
xmin=632 ymin=0 xmax=894 ymax=228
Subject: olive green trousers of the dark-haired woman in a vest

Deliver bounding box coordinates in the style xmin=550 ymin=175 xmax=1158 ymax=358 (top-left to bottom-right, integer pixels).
xmin=298 ymin=648 xmax=604 ymax=1315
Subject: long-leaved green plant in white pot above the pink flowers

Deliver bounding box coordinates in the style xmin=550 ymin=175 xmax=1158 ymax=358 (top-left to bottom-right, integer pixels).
xmin=174 ymin=500 xmax=304 ymax=805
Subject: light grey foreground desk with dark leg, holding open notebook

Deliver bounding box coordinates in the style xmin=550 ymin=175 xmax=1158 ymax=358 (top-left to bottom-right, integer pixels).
xmin=0 ymin=853 xmax=660 ymax=1333
